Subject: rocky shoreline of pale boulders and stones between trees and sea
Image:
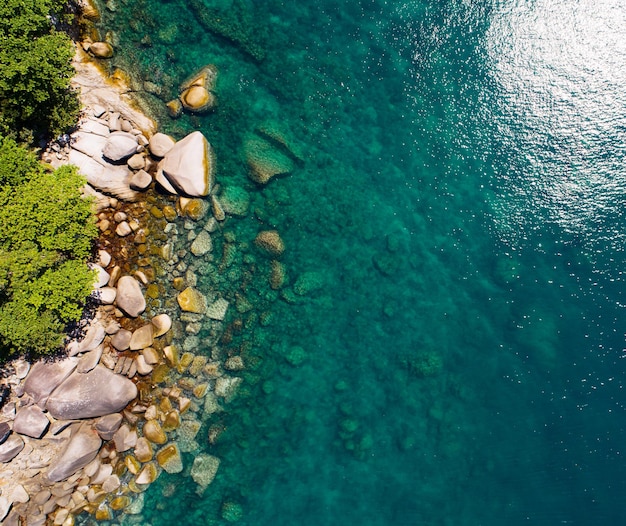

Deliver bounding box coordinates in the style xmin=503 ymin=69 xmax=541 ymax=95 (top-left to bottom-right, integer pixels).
xmin=0 ymin=32 xmax=245 ymax=525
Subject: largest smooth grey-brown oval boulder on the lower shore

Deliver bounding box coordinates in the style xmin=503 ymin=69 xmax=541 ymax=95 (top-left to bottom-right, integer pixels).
xmin=46 ymin=364 xmax=137 ymax=420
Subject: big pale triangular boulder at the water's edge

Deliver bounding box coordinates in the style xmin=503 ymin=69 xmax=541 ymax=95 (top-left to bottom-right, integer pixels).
xmin=157 ymin=131 xmax=215 ymax=197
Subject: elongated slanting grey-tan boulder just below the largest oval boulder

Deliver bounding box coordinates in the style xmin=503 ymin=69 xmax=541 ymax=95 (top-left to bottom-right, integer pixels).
xmin=47 ymin=424 xmax=102 ymax=482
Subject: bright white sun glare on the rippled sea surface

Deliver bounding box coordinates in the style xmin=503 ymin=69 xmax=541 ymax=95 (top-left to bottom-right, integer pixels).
xmin=486 ymin=0 xmax=626 ymax=249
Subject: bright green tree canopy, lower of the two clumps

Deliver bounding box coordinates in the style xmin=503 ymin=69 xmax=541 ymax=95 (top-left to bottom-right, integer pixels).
xmin=0 ymin=137 xmax=97 ymax=357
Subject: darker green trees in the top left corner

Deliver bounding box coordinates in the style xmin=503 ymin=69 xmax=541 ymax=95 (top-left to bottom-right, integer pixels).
xmin=0 ymin=0 xmax=80 ymax=143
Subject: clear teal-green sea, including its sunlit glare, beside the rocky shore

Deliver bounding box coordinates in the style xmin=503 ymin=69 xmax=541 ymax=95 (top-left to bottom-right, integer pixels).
xmin=94 ymin=0 xmax=626 ymax=526
